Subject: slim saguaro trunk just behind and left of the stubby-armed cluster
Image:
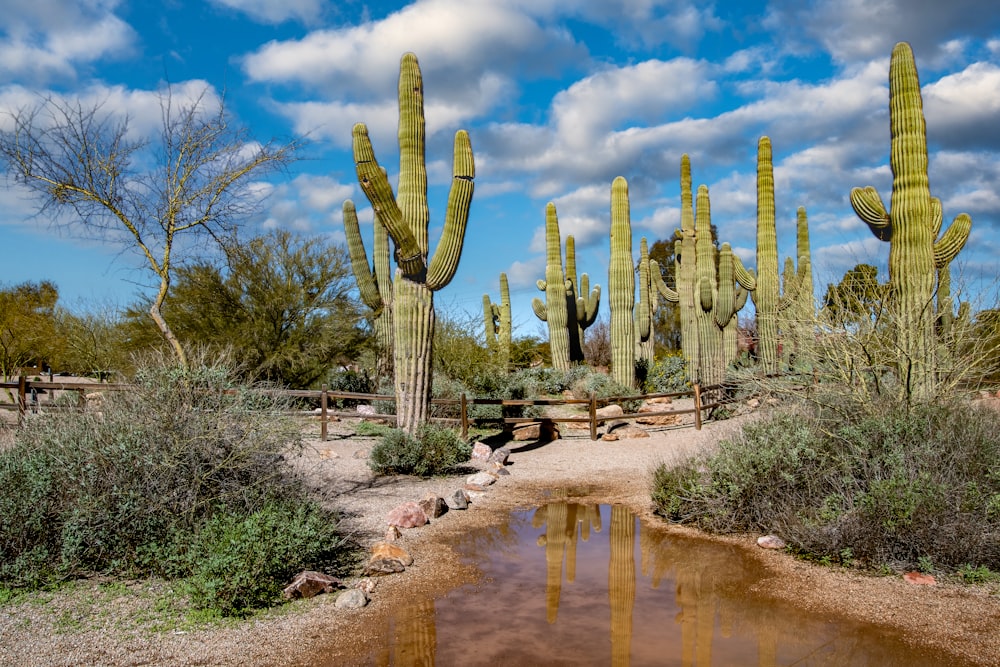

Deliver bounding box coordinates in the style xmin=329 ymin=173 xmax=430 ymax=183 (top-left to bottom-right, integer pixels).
xmin=674 ymin=154 xmax=701 ymax=382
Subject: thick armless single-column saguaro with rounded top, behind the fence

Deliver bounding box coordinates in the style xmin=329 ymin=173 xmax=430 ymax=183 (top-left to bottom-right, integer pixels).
xmin=608 ymin=176 xmax=635 ymax=388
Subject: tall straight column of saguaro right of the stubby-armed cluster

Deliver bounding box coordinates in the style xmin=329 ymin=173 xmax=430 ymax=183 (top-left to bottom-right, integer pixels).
xmin=753 ymin=137 xmax=781 ymax=375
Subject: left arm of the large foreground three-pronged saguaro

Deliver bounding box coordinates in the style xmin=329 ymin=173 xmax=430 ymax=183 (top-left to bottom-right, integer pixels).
xmin=353 ymin=123 xmax=425 ymax=276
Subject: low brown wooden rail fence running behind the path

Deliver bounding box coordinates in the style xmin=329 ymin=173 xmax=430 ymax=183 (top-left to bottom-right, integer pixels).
xmin=0 ymin=375 xmax=731 ymax=441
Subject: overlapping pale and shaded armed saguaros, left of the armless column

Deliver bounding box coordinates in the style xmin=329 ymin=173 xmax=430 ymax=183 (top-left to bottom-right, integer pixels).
xmin=531 ymin=202 xmax=601 ymax=371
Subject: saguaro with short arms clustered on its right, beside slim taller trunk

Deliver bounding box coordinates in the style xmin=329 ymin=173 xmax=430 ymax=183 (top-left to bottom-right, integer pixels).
xmin=693 ymin=185 xmax=757 ymax=385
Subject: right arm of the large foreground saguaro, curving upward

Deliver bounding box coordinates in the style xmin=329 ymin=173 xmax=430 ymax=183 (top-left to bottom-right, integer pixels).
xmin=427 ymin=130 xmax=476 ymax=290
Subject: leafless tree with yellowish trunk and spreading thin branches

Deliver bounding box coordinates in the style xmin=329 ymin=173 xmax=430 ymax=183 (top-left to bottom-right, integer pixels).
xmin=0 ymin=89 xmax=300 ymax=366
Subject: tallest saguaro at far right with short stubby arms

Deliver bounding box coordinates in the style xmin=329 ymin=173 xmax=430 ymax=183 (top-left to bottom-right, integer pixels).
xmin=851 ymin=42 xmax=972 ymax=400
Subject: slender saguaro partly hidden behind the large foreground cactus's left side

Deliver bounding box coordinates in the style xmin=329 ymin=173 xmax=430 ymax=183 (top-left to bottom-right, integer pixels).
xmin=344 ymin=199 xmax=392 ymax=377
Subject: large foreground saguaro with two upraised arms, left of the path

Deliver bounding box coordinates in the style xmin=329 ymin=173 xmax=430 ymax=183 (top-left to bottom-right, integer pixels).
xmin=353 ymin=53 xmax=475 ymax=434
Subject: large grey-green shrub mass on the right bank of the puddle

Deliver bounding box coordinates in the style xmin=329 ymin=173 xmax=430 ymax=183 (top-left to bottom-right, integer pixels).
xmin=652 ymin=397 xmax=1000 ymax=570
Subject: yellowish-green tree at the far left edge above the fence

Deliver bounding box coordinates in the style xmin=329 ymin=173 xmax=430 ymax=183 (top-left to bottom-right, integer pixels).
xmin=0 ymin=281 xmax=59 ymax=379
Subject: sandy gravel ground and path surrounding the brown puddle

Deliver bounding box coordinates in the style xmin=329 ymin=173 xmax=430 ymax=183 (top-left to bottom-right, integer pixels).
xmin=0 ymin=408 xmax=1000 ymax=665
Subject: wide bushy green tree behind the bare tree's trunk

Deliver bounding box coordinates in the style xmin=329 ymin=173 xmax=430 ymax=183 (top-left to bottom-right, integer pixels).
xmin=121 ymin=231 xmax=370 ymax=388
